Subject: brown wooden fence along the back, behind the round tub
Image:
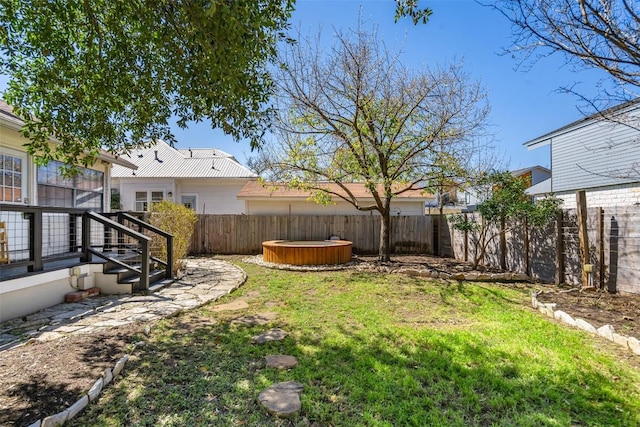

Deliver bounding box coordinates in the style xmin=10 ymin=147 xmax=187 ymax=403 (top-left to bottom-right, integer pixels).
xmin=190 ymin=215 xmax=434 ymax=254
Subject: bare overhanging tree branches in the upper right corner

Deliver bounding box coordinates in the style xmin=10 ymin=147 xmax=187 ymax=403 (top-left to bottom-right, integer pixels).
xmin=491 ymin=0 xmax=640 ymax=111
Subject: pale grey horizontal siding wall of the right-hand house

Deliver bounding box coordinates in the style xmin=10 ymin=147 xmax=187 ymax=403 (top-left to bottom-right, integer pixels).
xmin=551 ymin=109 xmax=640 ymax=193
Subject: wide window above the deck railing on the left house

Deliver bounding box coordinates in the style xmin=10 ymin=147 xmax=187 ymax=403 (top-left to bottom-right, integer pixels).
xmin=38 ymin=161 xmax=104 ymax=210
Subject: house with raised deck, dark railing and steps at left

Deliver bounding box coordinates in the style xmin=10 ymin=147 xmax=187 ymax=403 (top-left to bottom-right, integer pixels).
xmin=0 ymin=100 xmax=171 ymax=321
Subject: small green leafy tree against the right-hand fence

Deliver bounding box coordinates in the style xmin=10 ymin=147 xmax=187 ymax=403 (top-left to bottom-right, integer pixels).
xmin=451 ymin=172 xmax=562 ymax=268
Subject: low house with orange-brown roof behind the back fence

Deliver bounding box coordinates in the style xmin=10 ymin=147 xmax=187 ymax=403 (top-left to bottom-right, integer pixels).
xmin=237 ymin=181 xmax=434 ymax=216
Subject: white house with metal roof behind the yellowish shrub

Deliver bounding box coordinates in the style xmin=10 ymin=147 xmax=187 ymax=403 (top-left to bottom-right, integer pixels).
xmin=112 ymin=141 xmax=257 ymax=214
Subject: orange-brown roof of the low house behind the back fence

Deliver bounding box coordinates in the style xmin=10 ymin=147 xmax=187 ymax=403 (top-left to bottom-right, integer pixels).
xmin=237 ymin=181 xmax=434 ymax=201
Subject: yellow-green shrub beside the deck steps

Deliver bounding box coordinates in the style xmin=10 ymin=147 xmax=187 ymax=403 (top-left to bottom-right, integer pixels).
xmin=149 ymin=200 xmax=198 ymax=272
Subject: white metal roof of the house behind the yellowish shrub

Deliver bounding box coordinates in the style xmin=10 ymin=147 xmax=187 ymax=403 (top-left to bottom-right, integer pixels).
xmin=111 ymin=140 xmax=258 ymax=178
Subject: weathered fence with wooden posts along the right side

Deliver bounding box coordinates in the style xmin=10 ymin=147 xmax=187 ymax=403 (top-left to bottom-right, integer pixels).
xmin=445 ymin=206 xmax=640 ymax=293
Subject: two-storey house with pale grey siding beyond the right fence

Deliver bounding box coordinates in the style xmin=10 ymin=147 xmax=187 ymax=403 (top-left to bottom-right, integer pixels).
xmin=524 ymin=99 xmax=640 ymax=208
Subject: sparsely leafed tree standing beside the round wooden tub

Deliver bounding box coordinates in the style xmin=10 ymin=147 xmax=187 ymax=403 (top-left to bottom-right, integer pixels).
xmin=252 ymin=29 xmax=489 ymax=261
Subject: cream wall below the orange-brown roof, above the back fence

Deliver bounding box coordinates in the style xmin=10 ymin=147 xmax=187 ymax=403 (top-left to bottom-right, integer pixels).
xmin=245 ymin=200 xmax=425 ymax=216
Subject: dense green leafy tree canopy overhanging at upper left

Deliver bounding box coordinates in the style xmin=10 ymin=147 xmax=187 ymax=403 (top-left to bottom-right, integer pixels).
xmin=0 ymin=0 xmax=293 ymax=172
